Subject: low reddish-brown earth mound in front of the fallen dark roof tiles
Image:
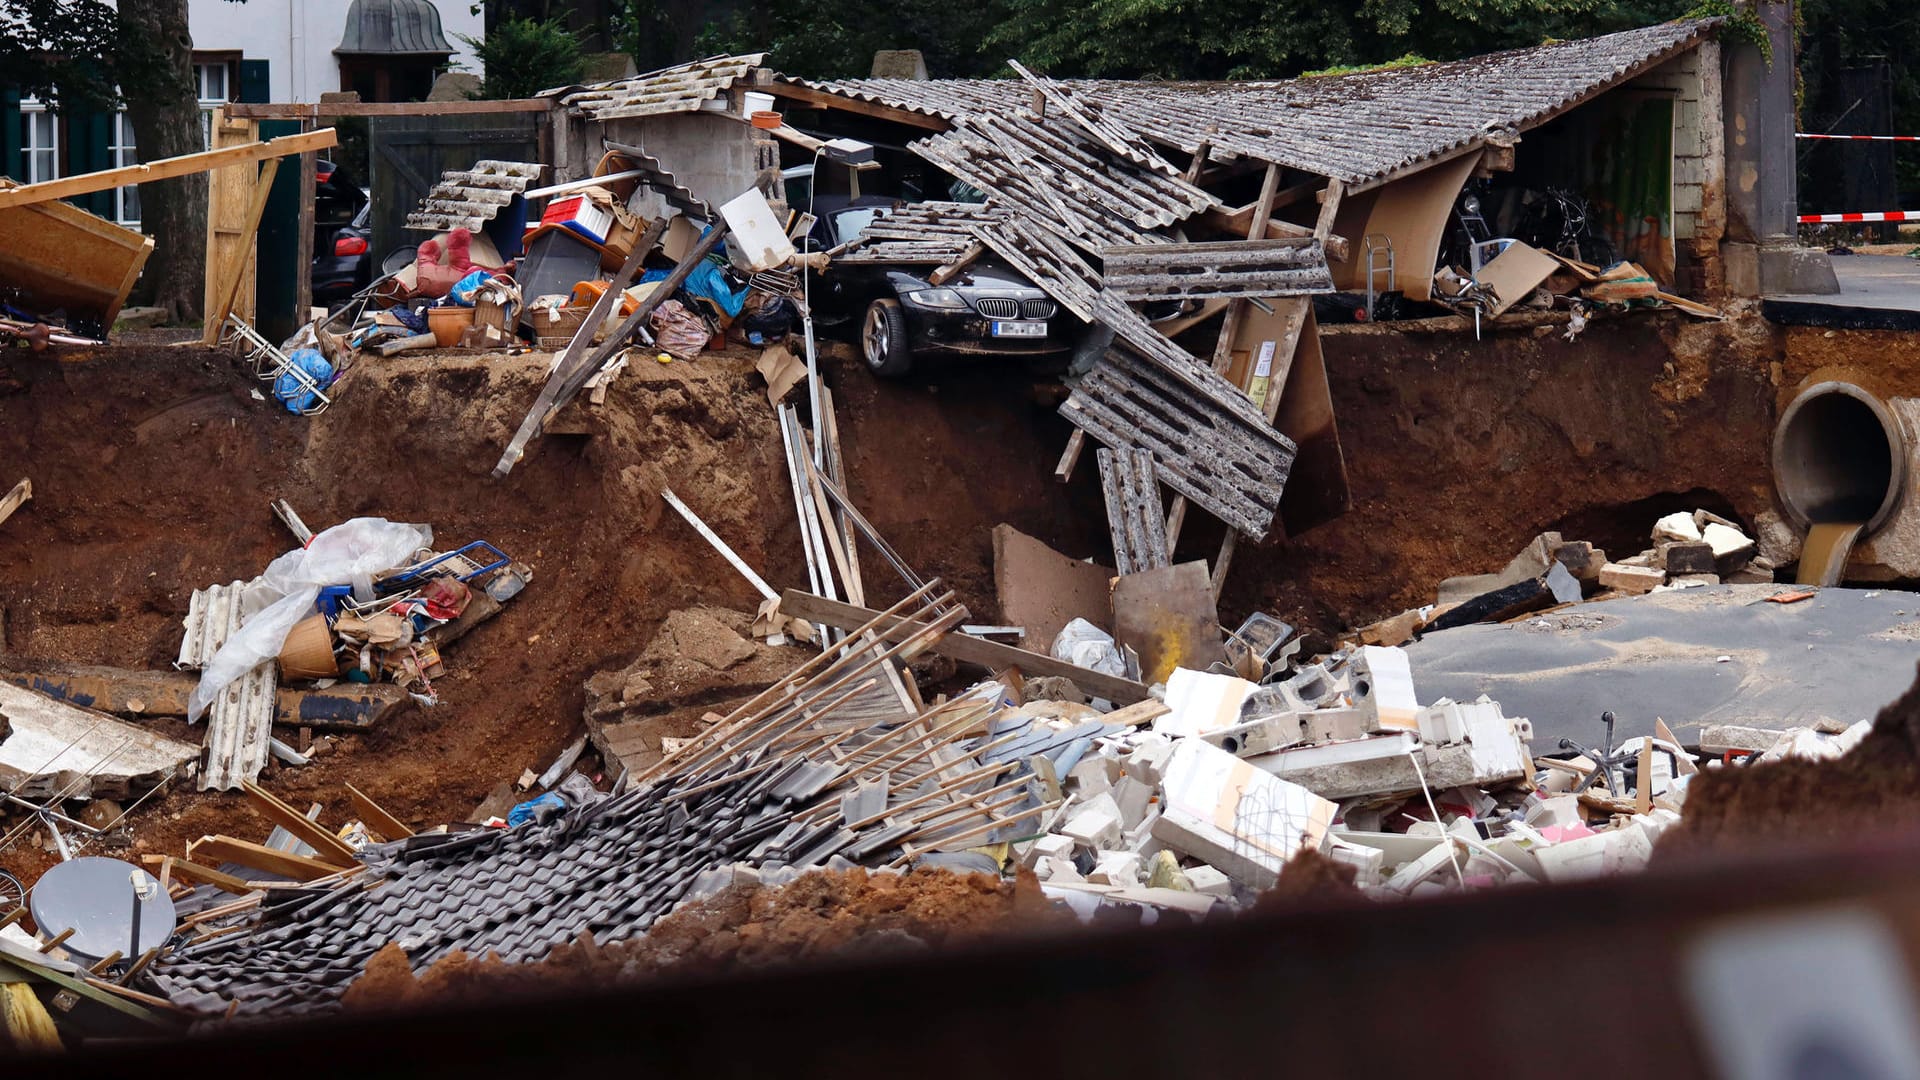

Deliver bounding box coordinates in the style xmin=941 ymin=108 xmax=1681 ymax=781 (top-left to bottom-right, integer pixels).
xmin=346 ymin=869 xmax=1077 ymax=1009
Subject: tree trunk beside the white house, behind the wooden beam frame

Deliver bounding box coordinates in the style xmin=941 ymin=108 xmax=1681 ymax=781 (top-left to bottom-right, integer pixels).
xmin=119 ymin=0 xmax=207 ymax=323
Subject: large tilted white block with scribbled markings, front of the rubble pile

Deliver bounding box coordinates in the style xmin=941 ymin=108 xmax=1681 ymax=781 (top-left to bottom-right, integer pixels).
xmin=1152 ymin=740 xmax=1334 ymax=888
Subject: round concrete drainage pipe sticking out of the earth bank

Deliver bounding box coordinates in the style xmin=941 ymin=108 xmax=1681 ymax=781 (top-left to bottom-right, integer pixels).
xmin=1774 ymin=382 xmax=1907 ymax=536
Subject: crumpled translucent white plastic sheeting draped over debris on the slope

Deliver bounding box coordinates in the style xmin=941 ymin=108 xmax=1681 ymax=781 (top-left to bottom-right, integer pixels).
xmin=186 ymin=517 xmax=434 ymax=721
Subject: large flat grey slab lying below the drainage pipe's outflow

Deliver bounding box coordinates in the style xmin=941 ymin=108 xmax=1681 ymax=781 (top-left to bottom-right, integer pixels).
xmin=1407 ymin=584 xmax=1920 ymax=753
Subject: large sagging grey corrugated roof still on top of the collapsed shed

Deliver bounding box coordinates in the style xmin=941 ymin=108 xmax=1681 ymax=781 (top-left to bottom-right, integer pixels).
xmin=810 ymin=19 xmax=1720 ymax=184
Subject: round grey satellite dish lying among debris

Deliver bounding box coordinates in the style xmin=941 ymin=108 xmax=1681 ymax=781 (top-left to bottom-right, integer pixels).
xmin=27 ymin=857 xmax=177 ymax=961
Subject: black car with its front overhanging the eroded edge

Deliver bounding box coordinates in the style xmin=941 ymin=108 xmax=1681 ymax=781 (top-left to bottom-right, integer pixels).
xmin=814 ymin=196 xmax=1081 ymax=375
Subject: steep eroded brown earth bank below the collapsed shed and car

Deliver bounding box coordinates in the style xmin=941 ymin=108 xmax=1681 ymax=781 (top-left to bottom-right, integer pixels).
xmin=0 ymin=307 xmax=1778 ymax=880
